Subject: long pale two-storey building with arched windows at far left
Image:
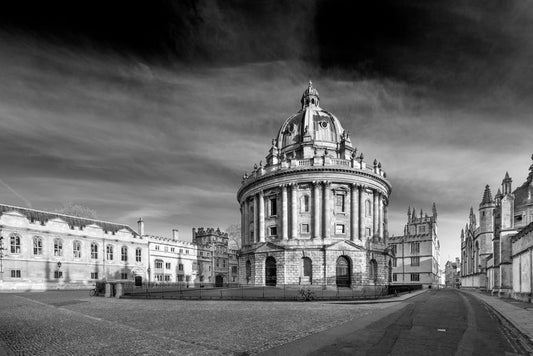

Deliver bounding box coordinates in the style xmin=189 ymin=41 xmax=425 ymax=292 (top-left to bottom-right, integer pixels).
xmin=0 ymin=205 xmax=149 ymax=290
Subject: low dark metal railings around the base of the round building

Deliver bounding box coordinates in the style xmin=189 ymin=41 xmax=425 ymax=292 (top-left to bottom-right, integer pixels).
xmin=124 ymin=283 xmax=394 ymax=300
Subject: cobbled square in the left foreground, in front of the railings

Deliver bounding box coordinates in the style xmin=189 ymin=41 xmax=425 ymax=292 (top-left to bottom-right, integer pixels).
xmin=0 ymin=291 xmax=398 ymax=355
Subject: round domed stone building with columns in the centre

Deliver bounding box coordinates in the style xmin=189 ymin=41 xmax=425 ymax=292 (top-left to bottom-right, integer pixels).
xmin=237 ymin=82 xmax=391 ymax=288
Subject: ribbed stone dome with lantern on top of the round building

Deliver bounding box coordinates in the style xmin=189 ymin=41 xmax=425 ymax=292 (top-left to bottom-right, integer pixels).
xmin=275 ymin=82 xmax=352 ymax=158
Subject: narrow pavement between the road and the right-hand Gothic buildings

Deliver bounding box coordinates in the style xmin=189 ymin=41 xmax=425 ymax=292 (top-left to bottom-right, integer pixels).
xmin=459 ymin=289 xmax=533 ymax=342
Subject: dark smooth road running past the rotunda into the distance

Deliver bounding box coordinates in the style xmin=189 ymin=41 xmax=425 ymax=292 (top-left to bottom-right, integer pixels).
xmin=265 ymin=289 xmax=533 ymax=355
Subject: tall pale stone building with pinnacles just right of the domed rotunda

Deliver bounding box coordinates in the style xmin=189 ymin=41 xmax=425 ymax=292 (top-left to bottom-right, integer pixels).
xmin=387 ymin=203 xmax=440 ymax=287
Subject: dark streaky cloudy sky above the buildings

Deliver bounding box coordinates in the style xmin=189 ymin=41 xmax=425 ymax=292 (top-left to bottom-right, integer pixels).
xmin=0 ymin=0 xmax=533 ymax=261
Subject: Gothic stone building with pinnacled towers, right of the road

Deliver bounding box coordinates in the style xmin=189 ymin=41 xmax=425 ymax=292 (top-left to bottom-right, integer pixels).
xmin=461 ymin=157 xmax=533 ymax=296
